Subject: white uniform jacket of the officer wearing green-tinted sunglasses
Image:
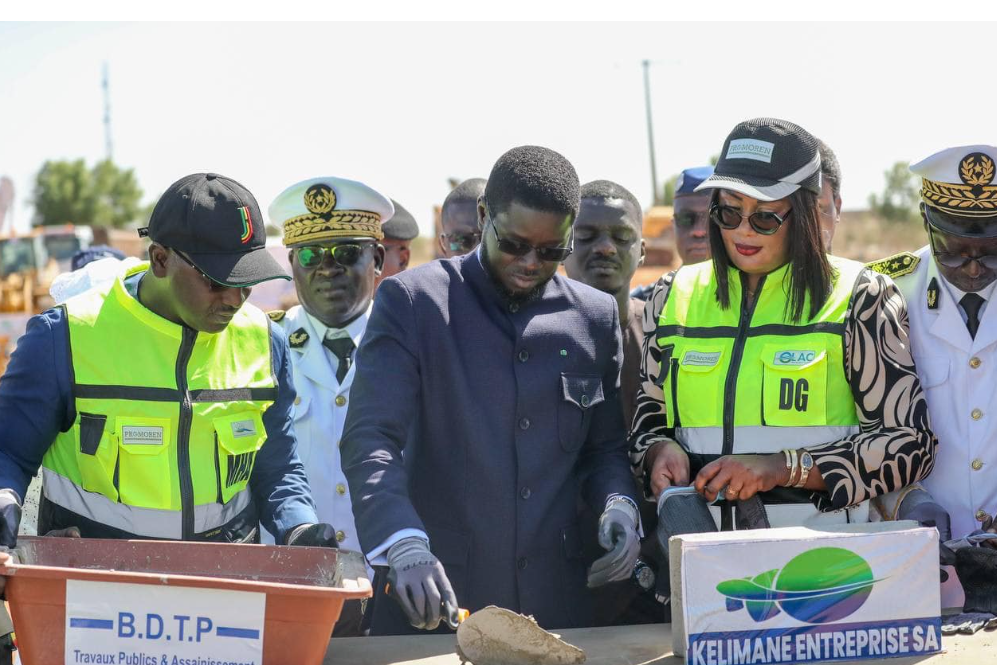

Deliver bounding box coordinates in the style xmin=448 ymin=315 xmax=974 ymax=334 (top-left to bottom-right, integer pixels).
xmin=263 ymin=305 xmax=370 ymax=572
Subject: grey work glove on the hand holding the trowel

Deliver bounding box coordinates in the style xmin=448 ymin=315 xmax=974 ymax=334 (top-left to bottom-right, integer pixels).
xmin=388 ymin=536 xmax=460 ymax=630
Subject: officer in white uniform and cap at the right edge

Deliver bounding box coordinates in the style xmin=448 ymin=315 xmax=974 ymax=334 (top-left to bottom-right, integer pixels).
xmin=872 ymin=145 xmax=997 ymax=607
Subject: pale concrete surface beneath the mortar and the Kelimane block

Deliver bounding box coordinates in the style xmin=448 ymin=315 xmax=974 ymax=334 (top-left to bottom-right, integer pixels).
xmin=324 ymin=624 xmax=997 ymax=665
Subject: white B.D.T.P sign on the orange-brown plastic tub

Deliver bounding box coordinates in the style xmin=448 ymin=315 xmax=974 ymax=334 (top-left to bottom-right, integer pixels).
xmin=65 ymin=580 xmax=266 ymax=665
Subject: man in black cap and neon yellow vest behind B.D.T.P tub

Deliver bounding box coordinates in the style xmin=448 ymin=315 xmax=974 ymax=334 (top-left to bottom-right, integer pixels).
xmin=0 ymin=174 xmax=336 ymax=572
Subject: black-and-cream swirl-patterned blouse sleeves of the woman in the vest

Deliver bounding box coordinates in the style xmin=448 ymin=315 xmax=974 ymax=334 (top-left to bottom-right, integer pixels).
xmin=630 ymin=269 xmax=937 ymax=511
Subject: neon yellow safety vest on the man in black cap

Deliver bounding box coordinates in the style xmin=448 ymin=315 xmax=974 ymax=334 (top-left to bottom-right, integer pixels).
xmin=43 ymin=264 xmax=277 ymax=539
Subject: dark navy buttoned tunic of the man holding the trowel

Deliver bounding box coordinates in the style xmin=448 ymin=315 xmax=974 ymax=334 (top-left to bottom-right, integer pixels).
xmin=342 ymin=253 xmax=634 ymax=634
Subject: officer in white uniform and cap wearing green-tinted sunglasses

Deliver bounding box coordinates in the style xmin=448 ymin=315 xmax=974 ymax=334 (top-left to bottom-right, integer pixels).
xmin=264 ymin=177 xmax=394 ymax=634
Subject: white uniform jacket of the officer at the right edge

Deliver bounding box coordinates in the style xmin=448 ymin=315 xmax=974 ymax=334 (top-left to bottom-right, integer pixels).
xmin=894 ymin=247 xmax=997 ymax=607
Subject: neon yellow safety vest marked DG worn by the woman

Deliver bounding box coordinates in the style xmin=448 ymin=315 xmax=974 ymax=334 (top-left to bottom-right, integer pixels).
xmin=656 ymin=257 xmax=868 ymax=528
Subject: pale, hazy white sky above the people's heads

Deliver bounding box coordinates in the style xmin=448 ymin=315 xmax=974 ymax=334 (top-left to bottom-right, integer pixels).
xmin=0 ymin=22 xmax=997 ymax=234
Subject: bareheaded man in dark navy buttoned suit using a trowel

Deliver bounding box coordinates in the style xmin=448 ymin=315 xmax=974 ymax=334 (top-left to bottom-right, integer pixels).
xmin=342 ymin=146 xmax=639 ymax=634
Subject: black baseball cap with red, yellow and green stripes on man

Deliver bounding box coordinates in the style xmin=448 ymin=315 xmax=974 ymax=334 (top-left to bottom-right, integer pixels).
xmin=139 ymin=173 xmax=291 ymax=287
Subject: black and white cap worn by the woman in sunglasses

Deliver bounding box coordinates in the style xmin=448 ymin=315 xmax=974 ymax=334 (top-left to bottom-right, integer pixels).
xmin=696 ymin=118 xmax=820 ymax=201
